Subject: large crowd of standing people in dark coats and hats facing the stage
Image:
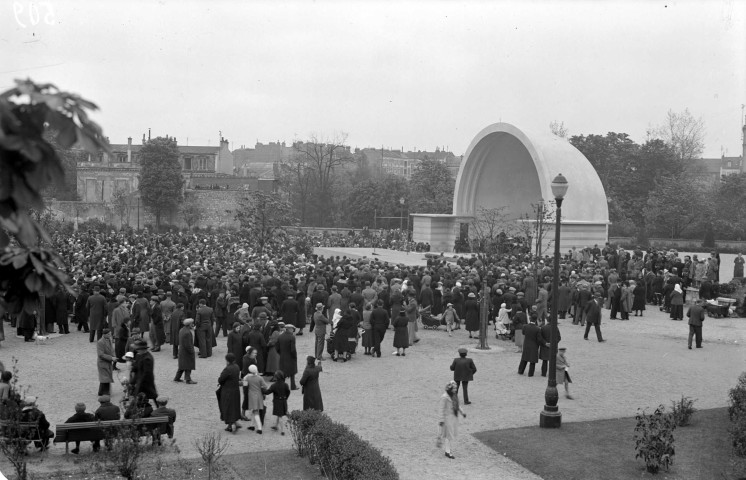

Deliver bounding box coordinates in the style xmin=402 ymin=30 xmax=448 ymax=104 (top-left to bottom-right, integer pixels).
xmin=0 ymin=225 xmax=743 ymax=457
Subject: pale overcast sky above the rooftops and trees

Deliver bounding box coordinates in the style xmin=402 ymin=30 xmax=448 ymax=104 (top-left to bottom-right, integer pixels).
xmin=0 ymin=0 xmax=746 ymax=157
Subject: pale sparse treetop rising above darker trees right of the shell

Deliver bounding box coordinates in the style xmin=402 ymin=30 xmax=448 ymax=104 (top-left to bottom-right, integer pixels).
xmin=648 ymin=108 xmax=705 ymax=166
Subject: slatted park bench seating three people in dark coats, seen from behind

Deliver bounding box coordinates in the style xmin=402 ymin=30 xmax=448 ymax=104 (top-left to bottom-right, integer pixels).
xmin=54 ymin=417 xmax=173 ymax=453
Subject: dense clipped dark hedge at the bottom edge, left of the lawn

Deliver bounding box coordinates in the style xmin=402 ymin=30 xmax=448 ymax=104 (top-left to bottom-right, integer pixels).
xmin=288 ymin=410 xmax=399 ymax=480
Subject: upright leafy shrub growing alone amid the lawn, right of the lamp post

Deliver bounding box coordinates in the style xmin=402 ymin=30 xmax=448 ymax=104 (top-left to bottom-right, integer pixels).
xmin=635 ymin=405 xmax=676 ymax=474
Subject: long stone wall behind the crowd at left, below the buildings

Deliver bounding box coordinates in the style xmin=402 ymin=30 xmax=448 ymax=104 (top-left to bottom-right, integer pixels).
xmin=47 ymin=190 xmax=246 ymax=228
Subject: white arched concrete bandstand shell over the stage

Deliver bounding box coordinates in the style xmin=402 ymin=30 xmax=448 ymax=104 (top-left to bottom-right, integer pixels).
xmin=453 ymin=123 xmax=609 ymax=224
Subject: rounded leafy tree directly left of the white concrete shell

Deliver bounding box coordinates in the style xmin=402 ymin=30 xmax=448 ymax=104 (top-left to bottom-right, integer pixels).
xmin=409 ymin=160 xmax=456 ymax=213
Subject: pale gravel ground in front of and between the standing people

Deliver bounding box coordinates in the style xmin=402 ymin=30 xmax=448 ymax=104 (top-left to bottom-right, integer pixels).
xmin=0 ymin=309 xmax=746 ymax=480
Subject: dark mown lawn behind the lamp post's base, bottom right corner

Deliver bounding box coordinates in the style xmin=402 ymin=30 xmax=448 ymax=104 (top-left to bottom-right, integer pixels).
xmin=474 ymin=408 xmax=746 ymax=480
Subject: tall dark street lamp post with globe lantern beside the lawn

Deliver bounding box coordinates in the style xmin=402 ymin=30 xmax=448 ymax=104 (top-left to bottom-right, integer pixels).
xmin=539 ymin=173 xmax=569 ymax=428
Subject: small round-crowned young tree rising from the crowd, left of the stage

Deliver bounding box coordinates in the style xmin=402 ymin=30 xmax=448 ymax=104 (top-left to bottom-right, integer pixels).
xmin=236 ymin=191 xmax=296 ymax=253
